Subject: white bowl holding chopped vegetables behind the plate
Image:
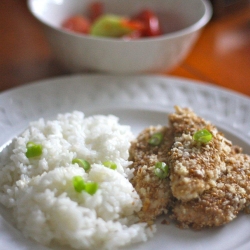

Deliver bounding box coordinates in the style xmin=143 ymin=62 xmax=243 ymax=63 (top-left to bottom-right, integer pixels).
xmin=28 ymin=0 xmax=212 ymax=74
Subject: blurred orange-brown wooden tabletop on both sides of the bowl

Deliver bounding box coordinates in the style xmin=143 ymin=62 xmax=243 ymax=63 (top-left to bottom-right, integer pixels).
xmin=0 ymin=0 xmax=250 ymax=96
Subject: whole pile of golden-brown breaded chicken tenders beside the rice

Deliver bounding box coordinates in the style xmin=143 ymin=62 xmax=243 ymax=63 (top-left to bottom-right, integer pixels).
xmin=130 ymin=107 xmax=250 ymax=229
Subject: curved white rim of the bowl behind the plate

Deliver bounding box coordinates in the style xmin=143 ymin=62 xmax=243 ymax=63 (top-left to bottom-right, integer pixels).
xmin=27 ymin=0 xmax=213 ymax=43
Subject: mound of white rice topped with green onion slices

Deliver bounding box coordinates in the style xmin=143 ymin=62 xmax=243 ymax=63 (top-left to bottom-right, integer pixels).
xmin=0 ymin=111 xmax=153 ymax=249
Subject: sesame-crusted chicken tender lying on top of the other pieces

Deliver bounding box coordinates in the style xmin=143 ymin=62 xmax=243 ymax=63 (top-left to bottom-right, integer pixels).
xmin=168 ymin=107 xmax=233 ymax=201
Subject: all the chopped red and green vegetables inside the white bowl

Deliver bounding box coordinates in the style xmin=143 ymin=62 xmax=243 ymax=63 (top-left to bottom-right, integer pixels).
xmin=62 ymin=1 xmax=162 ymax=39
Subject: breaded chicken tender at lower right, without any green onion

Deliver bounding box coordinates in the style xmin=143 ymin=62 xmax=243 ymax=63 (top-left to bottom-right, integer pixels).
xmin=173 ymin=154 xmax=250 ymax=229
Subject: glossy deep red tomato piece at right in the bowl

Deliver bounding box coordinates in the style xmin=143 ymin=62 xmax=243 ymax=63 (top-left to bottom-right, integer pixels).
xmin=133 ymin=9 xmax=162 ymax=36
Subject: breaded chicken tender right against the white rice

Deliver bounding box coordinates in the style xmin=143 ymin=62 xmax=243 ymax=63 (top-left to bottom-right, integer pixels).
xmin=130 ymin=126 xmax=172 ymax=224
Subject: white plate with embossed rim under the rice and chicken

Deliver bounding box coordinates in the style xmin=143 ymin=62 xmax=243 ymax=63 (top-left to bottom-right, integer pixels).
xmin=0 ymin=75 xmax=250 ymax=250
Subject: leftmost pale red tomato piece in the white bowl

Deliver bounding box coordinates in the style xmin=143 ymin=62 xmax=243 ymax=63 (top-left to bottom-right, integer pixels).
xmin=62 ymin=15 xmax=91 ymax=34
